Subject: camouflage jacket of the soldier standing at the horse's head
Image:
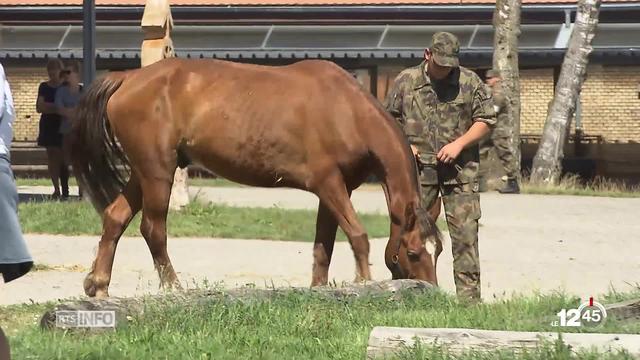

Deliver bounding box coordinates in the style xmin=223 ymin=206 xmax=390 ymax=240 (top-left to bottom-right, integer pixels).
xmin=384 ymin=62 xmax=496 ymax=185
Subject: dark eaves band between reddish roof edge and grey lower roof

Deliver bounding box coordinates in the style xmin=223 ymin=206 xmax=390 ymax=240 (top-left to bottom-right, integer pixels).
xmin=0 ymin=1 xmax=640 ymax=25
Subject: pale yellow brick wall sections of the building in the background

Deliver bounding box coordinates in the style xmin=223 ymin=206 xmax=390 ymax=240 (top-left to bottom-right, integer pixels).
xmin=5 ymin=64 xmax=640 ymax=142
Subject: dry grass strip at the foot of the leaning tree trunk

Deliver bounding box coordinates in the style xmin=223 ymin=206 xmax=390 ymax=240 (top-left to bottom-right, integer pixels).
xmin=520 ymin=174 xmax=640 ymax=198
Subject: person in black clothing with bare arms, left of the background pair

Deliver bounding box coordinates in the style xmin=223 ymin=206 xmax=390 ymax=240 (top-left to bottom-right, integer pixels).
xmin=36 ymin=59 xmax=63 ymax=199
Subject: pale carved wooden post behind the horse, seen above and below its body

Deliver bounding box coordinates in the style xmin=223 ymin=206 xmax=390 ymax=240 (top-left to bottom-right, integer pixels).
xmin=140 ymin=0 xmax=189 ymax=210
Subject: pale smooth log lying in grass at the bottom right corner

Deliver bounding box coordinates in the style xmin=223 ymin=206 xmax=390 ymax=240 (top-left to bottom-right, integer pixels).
xmin=367 ymin=326 xmax=640 ymax=359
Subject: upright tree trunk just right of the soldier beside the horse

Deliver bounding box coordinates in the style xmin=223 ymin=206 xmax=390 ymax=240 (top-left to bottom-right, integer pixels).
xmin=493 ymin=0 xmax=522 ymax=178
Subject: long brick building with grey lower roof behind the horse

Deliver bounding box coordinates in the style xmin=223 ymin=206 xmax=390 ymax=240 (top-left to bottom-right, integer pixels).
xmin=0 ymin=0 xmax=640 ymax=177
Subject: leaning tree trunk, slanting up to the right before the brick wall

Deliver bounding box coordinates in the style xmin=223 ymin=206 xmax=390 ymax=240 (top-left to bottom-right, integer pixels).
xmin=530 ymin=0 xmax=601 ymax=184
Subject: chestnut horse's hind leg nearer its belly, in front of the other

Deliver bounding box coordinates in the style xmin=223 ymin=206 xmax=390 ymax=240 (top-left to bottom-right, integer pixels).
xmin=140 ymin=173 xmax=181 ymax=288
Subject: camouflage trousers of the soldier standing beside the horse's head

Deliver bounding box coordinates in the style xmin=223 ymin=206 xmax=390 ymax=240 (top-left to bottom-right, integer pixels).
xmin=422 ymin=183 xmax=481 ymax=300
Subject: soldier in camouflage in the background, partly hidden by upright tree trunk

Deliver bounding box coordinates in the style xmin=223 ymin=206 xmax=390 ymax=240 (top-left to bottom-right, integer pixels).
xmin=480 ymin=69 xmax=520 ymax=194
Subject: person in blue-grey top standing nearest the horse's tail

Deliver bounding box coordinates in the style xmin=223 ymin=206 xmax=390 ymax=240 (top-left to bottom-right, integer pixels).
xmin=54 ymin=61 xmax=83 ymax=200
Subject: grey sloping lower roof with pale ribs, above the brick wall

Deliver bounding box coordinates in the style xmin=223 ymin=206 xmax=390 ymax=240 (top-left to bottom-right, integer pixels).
xmin=0 ymin=23 xmax=640 ymax=62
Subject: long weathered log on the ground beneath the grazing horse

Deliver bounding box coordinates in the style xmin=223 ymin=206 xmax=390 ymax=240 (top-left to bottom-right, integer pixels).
xmin=40 ymin=279 xmax=437 ymax=331
